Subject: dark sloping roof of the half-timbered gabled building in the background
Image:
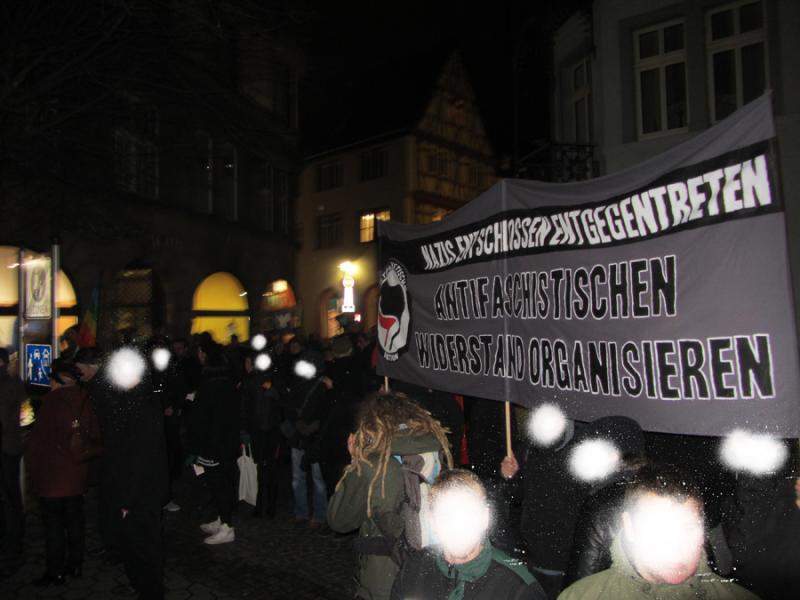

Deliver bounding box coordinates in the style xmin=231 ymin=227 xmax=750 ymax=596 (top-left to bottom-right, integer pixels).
xmin=300 ymin=50 xmax=452 ymax=158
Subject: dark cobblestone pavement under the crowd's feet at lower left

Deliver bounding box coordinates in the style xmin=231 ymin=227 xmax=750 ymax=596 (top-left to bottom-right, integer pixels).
xmin=0 ymin=464 xmax=355 ymax=600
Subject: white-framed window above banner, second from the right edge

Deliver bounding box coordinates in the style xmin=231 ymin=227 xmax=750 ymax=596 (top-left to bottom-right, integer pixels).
xmin=633 ymin=20 xmax=689 ymax=138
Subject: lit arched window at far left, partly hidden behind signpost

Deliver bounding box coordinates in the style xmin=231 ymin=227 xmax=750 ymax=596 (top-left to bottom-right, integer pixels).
xmin=0 ymin=246 xmax=78 ymax=349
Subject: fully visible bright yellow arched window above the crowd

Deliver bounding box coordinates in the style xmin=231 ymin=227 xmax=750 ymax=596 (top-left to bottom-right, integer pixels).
xmin=192 ymin=272 xmax=250 ymax=344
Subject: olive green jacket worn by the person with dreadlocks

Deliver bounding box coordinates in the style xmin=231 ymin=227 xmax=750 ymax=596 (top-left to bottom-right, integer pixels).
xmin=328 ymin=433 xmax=442 ymax=600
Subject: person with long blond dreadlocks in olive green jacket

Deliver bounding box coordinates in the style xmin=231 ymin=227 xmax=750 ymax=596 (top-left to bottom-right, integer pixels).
xmin=328 ymin=393 xmax=453 ymax=600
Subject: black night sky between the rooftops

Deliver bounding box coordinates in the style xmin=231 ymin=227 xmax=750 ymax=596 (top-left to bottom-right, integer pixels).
xmin=301 ymin=0 xmax=586 ymax=161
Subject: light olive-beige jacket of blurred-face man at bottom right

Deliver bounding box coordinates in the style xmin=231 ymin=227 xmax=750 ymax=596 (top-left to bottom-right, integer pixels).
xmin=558 ymin=536 xmax=758 ymax=600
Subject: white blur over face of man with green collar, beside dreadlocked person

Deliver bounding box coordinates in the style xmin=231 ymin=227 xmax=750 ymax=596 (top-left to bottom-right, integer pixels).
xmin=432 ymin=488 xmax=489 ymax=558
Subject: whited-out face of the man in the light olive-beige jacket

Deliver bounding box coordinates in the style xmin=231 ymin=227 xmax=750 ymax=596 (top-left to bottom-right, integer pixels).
xmin=622 ymin=493 xmax=704 ymax=585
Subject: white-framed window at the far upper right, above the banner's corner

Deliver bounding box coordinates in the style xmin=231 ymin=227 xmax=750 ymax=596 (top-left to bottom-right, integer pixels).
xmin=706 ymin=0 xmax=767 ymax=121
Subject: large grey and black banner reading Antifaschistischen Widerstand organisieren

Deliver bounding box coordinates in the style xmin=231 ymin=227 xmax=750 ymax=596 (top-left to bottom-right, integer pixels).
xmin=378 ymin=99 xmax=800 ymax=436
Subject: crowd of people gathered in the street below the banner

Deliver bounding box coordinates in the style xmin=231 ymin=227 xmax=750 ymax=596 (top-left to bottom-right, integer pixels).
xmin=0 ymin=332 xmax=800 ymax=600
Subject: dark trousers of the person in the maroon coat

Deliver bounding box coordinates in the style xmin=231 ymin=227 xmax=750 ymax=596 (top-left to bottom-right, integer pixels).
xmin=39 ymin=496 xmax=85 ymax=575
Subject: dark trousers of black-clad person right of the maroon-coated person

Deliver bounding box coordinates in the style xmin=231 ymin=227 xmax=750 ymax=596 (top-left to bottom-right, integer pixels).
xmin=116 ymin=506 xmax=164 ymax=600
